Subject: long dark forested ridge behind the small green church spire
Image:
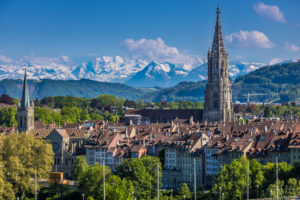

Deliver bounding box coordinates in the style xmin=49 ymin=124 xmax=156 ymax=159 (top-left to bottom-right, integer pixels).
xmin=0 ymin=79 xmax=145 ymax=99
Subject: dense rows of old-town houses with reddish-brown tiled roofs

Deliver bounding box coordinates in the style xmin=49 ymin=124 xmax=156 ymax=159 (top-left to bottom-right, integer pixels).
xmin=2 ymin=117 xmax=300 ymax=189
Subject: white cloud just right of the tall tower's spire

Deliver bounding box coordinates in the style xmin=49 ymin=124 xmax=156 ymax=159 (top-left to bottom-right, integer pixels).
xmin=225 ymin=30 xmax=274 ymax=48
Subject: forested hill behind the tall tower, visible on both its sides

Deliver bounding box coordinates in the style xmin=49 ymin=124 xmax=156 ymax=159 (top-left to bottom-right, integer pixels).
xmin=142 ymin=62 xmax=300 ymax=103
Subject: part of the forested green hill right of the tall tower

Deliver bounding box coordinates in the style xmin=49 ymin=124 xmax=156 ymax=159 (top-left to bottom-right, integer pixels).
xmin=232 ymin=62 xmax=300 ymax=103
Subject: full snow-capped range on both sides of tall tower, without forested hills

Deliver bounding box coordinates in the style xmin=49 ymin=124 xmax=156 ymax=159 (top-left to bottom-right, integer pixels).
xmin=0 ymin=56 xmax=265 ymax=87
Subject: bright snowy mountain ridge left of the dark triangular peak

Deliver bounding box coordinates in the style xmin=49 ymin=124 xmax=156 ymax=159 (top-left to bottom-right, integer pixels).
xmin=0 ymin=56 xmax=149 ymax=82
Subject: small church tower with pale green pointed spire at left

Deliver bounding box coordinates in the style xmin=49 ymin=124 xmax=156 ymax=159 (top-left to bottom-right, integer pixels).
xmin=17 ymin=70 xmax=34 ymax=133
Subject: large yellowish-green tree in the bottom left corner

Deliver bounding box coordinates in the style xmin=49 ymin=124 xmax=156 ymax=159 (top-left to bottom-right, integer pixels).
xmin=0 ymin=133 xmax=54 ymax=197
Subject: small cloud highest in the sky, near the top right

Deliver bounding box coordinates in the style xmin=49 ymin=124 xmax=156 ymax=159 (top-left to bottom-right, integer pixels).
xmin=253 ymin=2 xmax=286 ymax=22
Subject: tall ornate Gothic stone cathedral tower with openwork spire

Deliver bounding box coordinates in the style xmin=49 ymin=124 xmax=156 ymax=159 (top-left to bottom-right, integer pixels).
xmin=203 ymin=7 xmax=234 ymax=122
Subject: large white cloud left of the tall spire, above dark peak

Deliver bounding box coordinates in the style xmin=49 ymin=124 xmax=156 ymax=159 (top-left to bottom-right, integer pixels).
xmin=121 ymin=38 xmax=204 ymax=64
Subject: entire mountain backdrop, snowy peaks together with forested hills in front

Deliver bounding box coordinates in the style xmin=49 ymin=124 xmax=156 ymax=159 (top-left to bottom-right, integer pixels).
xmin=0 ymin=57 xmax=300 ymax=103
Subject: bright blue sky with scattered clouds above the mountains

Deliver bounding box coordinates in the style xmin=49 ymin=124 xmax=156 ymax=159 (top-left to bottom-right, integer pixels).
xmin=0 ymin=0 xmax=300 ymax=63
